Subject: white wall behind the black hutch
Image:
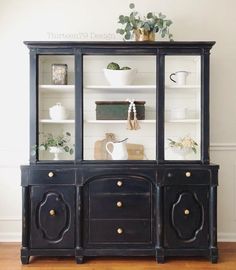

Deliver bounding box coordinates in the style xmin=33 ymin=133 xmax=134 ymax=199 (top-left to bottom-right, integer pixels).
xmin=0 ymin=0 xmax=236 ymax=241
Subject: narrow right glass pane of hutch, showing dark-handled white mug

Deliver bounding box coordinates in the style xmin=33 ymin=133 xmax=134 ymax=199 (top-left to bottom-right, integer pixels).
xmin=165 ymin=56 xmax=201 ymax=160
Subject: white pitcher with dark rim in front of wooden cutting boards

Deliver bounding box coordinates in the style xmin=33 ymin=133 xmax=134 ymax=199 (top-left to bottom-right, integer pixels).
xmin=106 ymin=138 xmax=128 ymax=160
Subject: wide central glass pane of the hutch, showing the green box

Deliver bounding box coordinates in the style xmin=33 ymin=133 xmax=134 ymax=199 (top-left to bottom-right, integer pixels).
xmin=83 ymin=55 xmax=156 ymax=160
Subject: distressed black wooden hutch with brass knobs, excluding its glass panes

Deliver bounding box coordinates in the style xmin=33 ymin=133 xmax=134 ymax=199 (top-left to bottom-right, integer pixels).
xmin=21 ymin=42 xmax=218 ymax=264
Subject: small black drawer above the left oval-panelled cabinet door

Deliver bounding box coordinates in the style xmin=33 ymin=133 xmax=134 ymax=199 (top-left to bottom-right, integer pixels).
xmin=29 ymin=168 xmax=75 ymax=185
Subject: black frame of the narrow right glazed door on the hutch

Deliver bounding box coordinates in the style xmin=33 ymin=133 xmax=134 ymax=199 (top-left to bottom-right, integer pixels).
xmin=157 ymin=47 xmax=210 ymax=164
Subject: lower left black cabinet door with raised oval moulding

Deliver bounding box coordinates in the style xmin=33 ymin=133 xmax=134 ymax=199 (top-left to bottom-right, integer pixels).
xmin=31 ymin=186 xmax=75 ymax=248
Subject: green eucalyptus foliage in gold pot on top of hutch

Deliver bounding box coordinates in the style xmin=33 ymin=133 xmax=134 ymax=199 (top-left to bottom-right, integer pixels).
xmin=116 ymin=3 xmax=173 ymax=41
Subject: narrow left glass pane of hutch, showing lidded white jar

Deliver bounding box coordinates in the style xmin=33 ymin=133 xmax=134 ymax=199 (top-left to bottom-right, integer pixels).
xmin=38 ymin=55 xmax=75 ymax=160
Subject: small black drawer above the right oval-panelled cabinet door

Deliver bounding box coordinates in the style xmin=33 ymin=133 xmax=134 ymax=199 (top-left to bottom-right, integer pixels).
xmin=164 ymin=168 xmax=211 ymax=185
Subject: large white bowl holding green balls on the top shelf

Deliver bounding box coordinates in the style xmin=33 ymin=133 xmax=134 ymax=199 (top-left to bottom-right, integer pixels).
xmin=103 ymin=68 xmax=136 ymax=86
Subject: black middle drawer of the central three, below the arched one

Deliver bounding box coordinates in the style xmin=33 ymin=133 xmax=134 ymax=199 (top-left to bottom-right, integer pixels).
xmin=89 ymin=194 xmax=151 ymax=219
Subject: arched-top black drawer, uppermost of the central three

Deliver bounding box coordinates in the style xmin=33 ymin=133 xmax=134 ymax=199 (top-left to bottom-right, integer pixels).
xmin=89 ymin=177 xmax=151 ymax=194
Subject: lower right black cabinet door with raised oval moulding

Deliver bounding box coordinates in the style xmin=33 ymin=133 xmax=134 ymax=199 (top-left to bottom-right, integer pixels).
xmin=164 ymin=186 xmax=209 ymax=248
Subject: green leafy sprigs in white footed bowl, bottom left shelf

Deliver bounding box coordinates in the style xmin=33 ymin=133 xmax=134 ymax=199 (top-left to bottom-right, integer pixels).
xmin=31 ymin=132 xmax=74 ymax=156
